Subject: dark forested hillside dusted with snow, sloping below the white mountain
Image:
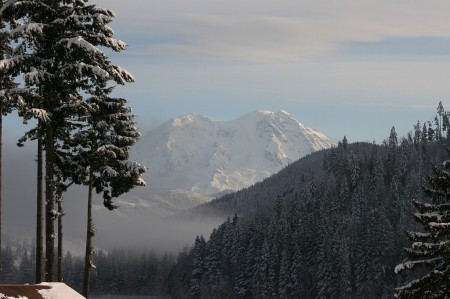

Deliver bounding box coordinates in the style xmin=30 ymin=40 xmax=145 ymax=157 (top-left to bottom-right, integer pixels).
xmin=169 ymin=135 xmax=449 ymax=298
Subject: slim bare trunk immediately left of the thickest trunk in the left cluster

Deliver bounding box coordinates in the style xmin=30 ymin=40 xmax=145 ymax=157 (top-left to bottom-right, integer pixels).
xmin=36 ymin=136 xmax=44 ymax=283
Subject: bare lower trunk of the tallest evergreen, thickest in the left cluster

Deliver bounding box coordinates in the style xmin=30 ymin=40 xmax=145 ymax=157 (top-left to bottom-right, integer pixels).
xmin=45 ymin=122 xmax=57 ymax=282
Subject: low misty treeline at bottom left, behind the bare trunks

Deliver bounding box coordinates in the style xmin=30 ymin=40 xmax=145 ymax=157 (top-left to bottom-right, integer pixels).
xmin=2 ymin=242 xmax=175 ymax=296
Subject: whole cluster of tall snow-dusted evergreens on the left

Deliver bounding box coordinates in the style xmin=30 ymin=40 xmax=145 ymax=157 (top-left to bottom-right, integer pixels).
xmin=0 ymin=0 xmax=145 ymax=297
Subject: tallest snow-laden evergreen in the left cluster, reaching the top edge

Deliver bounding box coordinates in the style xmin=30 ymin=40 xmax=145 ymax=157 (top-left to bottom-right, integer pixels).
xmin=2 ymin=0 xmax=139 ymax=281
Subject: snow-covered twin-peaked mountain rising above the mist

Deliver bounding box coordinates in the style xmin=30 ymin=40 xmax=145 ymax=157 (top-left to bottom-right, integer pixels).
xmin=132 ymin=110 xmax=334 ymax=195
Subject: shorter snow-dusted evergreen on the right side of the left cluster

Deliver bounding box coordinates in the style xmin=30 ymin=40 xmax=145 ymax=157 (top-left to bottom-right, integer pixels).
xmin=72 ymin=90 xmax=145 ymax=297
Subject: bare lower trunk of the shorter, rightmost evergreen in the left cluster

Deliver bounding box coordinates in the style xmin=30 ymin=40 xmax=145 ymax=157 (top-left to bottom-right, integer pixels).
xmin=83 ymin=167 xmax=94 ymax=298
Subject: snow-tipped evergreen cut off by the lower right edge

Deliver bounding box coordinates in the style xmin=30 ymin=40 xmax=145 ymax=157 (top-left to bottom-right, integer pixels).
xmin=395 ymin=155 xmax=450 ymax=298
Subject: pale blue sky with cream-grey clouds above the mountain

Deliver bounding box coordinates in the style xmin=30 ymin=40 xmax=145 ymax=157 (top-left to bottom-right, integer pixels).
xmin=6 ymin=0 xmax=450 ymax=142
